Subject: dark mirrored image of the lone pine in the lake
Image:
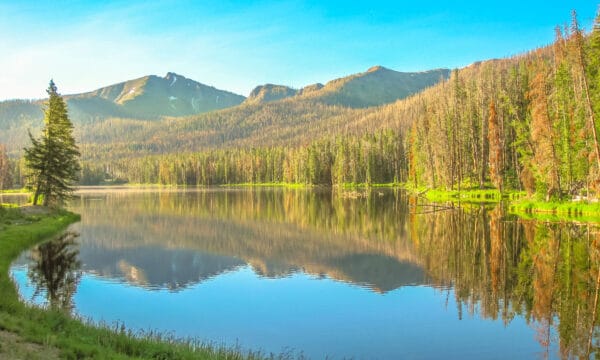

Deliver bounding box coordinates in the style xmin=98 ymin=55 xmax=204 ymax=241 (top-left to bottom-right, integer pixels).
xmin=28 ymin=232 xmax=81 ymax=313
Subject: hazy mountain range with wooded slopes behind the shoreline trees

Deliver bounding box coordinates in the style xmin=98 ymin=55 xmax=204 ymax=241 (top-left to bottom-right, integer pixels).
xmin=0 ymin=66 xmax=449 ymax=160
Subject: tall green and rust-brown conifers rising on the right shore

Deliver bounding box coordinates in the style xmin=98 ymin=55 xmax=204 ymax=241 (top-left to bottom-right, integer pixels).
xmin=406 ymin=13 xmax=600 ymax=199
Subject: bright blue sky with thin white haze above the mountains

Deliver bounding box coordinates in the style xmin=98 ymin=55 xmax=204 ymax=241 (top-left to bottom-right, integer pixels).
xmin=0 ymin=0 xmax=599 ymax=100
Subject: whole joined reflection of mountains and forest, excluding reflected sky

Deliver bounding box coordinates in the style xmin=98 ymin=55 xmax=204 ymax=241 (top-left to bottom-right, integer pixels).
xmin=64 ymin=189 xmax=600 ymax=358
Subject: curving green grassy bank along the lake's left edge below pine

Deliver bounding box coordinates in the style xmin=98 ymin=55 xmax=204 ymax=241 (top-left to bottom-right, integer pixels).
xmin=0 ymin=208 xmax=270 ymax=359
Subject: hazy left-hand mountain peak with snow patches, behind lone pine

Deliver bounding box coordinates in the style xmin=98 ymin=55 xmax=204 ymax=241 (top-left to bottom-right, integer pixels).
xmin=0 ymin=73 xmax=244 ymax=129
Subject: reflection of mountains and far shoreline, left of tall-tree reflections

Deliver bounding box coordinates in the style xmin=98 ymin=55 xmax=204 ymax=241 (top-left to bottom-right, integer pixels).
xmin=69 ymin=189 xmax=425 ymax=292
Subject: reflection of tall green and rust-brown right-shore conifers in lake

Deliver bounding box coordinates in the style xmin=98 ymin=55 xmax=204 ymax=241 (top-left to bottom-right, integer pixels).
xmin=410 ymin=202 xmax=600 ymax=358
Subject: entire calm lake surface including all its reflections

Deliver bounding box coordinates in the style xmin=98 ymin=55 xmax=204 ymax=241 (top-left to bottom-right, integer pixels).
xmin=11 ymin=189 xmax=600 ymax=359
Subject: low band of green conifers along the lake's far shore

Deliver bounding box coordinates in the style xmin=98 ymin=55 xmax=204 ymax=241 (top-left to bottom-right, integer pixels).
xmin=81 ymin=130 xmax=407 ymax=185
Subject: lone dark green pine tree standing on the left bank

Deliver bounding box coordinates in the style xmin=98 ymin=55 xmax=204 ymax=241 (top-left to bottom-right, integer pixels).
xmin=25 ymin=80 xmax=80 ymax=206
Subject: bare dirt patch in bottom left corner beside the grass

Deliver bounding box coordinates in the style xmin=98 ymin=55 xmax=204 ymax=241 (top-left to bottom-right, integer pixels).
xmin=0 ymin=330 xmax=59 ymax=360
